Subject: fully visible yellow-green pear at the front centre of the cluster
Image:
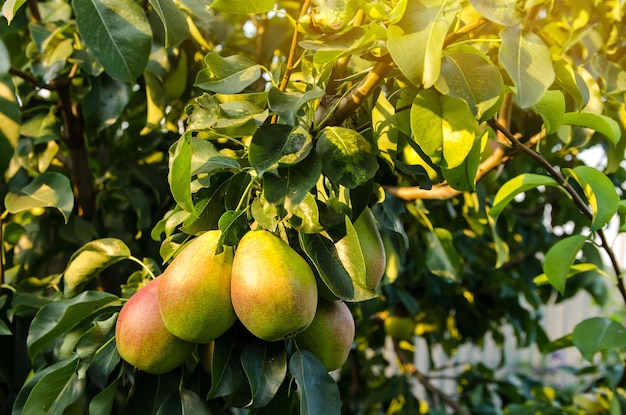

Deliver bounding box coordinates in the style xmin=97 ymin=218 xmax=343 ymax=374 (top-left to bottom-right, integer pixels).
xmin=231 ymin=230 xmax=317 ymax=341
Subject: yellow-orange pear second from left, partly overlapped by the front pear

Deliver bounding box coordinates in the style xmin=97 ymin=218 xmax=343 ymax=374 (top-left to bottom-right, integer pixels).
xmin=159 ymin=230 xmax=237 ymax=343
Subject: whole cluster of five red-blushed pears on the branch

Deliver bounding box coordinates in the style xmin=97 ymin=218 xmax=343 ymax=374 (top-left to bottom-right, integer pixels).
xmin=115 ymin=209 xmax=385 ymax=374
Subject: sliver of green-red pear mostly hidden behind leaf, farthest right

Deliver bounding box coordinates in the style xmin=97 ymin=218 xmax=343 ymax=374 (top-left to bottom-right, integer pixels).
xmin=353 ymin=208 xmax=387 ymax=289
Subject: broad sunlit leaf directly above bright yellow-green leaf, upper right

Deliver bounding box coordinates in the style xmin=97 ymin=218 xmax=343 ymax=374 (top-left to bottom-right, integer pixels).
xmin=435 ymin=45 xmax=502 ymax=119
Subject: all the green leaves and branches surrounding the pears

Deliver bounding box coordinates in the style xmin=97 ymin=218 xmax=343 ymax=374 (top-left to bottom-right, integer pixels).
xmin=0 ymin=0 xmax=626 ymax=415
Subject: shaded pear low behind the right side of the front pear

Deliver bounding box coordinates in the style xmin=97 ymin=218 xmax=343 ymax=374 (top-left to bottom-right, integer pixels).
xmin=296 ymin=299 xmax=355 ymax=372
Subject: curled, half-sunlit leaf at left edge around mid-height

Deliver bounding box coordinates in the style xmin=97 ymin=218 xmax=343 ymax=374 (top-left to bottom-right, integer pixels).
xmin=4 ymin=172 xmax=74 ymax=223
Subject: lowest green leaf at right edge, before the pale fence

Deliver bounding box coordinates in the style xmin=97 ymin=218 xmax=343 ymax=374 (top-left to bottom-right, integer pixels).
xmin=572 ymin=317 xmax=626 ymax=362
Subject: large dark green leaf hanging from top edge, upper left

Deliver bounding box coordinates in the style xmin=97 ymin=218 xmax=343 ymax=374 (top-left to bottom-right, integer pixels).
xmin=72 ymin=0 xmax=152 ymax=83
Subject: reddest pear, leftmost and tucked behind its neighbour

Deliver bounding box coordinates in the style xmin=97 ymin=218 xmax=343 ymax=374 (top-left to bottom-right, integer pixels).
xmin=115 ymin=277 xmax=195 ymax=375
